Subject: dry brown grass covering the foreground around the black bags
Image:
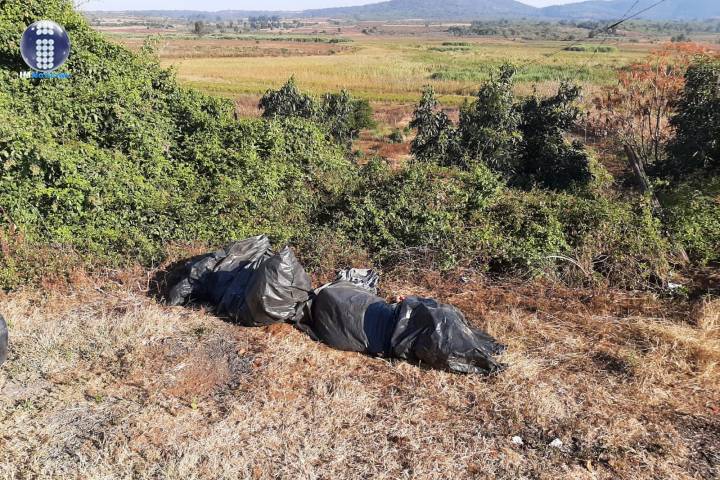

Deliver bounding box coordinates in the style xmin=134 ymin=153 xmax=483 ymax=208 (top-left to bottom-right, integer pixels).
xmin=0 ymin=272 xmax=720 ymax=479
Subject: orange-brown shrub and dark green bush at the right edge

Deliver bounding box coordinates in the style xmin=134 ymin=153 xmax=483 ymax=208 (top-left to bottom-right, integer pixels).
xmin=590 ymin=44 xmax=720 ymax=267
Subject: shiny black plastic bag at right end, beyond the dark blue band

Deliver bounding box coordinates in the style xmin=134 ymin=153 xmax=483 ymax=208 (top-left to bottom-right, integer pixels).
xmin=390 ymin=297 xmax=505 ymax=374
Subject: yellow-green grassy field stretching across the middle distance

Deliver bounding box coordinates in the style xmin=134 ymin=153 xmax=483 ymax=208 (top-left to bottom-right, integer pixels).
xmin=111 ymin=36 xmax=657 ymax=105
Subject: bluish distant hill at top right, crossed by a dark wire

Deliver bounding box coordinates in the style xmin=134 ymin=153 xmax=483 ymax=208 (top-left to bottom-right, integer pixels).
xmin=541 ymin=0 xmax=720 ymax=20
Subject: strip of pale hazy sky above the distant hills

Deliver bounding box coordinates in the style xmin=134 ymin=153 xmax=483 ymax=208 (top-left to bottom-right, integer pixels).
xmin=81 ymin=0 xmax=579 ymax=11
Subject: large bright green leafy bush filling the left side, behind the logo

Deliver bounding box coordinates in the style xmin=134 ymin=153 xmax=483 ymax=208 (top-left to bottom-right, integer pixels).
xmin=0 ymin=1 xmax=355 ymax=284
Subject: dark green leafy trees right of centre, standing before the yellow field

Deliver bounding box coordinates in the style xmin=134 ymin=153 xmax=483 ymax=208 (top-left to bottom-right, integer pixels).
xmin=410 ymin=65 xmax=593 ymax=190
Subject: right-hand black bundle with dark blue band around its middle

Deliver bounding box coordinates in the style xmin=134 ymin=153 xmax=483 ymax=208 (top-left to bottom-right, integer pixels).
xmin=299 ymin=270 xmax=505 ymax=374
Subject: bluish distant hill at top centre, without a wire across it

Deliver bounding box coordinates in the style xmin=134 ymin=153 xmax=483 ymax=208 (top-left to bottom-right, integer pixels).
xmin=303 ymin=0 xmax=540 ymax=20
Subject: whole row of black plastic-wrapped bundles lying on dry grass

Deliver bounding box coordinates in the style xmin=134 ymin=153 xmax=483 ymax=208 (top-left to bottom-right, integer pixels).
xmin=170 ymin=236 xmax=505 ymax=374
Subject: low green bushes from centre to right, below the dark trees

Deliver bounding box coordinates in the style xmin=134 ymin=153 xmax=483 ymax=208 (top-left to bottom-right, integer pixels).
xmin=326 ymin=160 xmax=669 ymax=287
